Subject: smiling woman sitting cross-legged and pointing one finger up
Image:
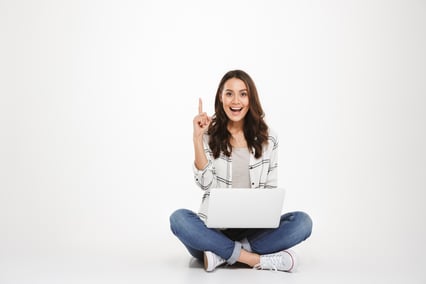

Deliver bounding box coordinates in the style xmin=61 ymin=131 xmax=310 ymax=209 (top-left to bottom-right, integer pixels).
xmin=170 ymin=70 xmax=312 ymax=272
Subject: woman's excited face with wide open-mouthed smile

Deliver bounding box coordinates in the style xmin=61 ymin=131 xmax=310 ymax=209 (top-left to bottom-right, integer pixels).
xmin=220 ymin=78 xmax=249 ymax=122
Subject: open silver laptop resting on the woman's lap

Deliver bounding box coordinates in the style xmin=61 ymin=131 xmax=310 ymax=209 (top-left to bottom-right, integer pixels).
xmin=206 ymin=188 xmax=285 ymax=228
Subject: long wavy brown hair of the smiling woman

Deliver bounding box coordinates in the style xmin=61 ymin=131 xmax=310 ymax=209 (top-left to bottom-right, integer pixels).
xmin=207 ymin=70 xmax=268 ymax=159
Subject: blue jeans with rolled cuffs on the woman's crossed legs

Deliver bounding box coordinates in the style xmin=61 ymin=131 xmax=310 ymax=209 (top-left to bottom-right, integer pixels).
xmin=170 ymin=209 xmax=312 ymax=264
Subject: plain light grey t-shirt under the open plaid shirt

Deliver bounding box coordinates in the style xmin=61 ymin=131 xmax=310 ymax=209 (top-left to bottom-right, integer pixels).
xmin=232 ymin=148 xmax=250 ymax=188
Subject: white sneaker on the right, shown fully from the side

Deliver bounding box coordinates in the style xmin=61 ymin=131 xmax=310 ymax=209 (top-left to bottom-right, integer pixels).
xmin=253 ymin=250 xmax=296 ymax=272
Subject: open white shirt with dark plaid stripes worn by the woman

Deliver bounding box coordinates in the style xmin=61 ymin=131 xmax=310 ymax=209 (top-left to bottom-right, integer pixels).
xmin=193 ymin=129 xmax=278 ymax=220
